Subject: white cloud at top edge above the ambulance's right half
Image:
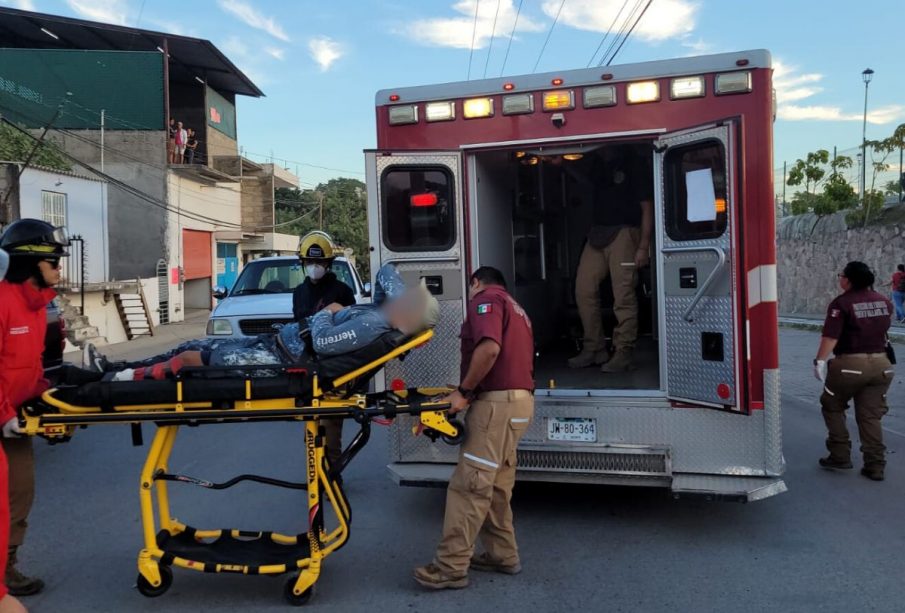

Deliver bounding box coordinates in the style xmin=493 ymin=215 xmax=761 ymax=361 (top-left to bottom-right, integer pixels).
xmin=541 ymin=0 xmax=698 ymax=42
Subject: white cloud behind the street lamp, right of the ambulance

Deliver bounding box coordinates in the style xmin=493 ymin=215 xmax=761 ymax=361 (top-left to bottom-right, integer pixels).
xmin=773 ymin=60 xmax=905 ymax=124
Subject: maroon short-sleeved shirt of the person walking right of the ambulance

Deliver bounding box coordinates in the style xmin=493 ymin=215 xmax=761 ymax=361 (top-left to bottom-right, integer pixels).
xmin=823 ymin=289 xmax=892 ymax=355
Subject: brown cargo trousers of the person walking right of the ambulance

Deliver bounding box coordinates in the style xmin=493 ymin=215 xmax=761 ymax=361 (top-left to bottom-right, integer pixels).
xmin=820 ymin=353 xmax=894 ymax=467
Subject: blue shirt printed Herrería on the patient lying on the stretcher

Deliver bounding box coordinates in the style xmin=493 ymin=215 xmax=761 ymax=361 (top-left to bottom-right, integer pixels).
xmin=309 ymin=264 xmax=405 ymax=355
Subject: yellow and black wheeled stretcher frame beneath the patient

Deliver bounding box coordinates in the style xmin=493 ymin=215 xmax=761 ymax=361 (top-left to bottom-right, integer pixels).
xmin=22 ymin=330 xmax=464 ymax=606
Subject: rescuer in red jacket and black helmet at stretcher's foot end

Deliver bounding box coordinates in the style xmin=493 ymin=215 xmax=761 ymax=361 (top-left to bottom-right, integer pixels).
xmin=0 ymin=219 xmax=69 ymax=596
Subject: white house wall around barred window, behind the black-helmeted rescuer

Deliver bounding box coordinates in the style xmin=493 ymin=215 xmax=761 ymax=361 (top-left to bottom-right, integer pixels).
xmin=19 ymin=167 xmax=110 ymax=283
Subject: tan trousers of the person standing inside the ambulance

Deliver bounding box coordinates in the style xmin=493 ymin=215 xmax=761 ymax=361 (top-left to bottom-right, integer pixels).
xmin=575 ymin=228 xmax=641 ymax=352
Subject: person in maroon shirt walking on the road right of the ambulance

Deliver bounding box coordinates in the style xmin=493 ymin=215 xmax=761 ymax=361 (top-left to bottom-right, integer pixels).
xmin=814 ymin=262 xmax=894 ymax=481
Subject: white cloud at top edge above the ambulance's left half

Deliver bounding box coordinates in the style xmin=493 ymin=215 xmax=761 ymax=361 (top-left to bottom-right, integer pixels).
xmin=405 ymin=0 xmax=544 ymax=49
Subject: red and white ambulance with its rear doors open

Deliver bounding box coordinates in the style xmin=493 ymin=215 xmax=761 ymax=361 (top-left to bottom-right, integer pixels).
xmin=365 ymin=50 xmax=786 ymax=501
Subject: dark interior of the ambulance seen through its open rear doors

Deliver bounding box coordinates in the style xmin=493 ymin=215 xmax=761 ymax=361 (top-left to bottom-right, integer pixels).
xmin=469 ymin=142 xmax=661 ymax=390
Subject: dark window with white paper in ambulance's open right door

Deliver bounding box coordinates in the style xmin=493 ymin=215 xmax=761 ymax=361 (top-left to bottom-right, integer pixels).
xmin=664 ymin=140 xmax=729 ymax=241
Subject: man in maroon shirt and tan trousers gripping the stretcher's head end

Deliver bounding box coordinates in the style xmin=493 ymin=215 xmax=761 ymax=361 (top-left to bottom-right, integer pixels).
xmin=414 ymin=266 xmax=534 ymax=590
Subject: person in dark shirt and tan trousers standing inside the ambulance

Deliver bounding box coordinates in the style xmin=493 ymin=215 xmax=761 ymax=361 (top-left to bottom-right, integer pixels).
xmin=569 ymin=146 xmax=654 ymax=373
